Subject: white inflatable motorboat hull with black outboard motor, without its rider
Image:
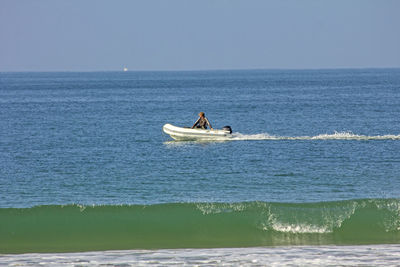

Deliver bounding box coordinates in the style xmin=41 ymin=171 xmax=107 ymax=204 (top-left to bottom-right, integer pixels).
xmin=163 ymin=123 xmax=232 ymax=141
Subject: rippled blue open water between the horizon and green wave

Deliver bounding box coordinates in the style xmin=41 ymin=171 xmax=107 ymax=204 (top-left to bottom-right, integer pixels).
xmin=0 ymin=69 xmax=400 ymax=207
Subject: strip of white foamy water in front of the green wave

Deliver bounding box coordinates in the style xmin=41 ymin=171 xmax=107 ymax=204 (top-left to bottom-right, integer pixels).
xmin=0 ymin=244 xmax=400 ymax=266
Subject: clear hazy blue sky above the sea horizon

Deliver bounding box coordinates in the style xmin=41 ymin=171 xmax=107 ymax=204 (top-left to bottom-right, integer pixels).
xmin=0 ymin=0 xmax=400 ymax=71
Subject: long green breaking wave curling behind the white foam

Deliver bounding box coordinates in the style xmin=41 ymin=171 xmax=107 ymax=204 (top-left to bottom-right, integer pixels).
xmin=0 ymin=199 xmax=400 ymax=253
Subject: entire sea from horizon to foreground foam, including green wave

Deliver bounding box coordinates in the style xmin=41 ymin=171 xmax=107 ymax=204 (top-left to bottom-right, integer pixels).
xmin=0 ymin=69 xmax=400 ymax=266
